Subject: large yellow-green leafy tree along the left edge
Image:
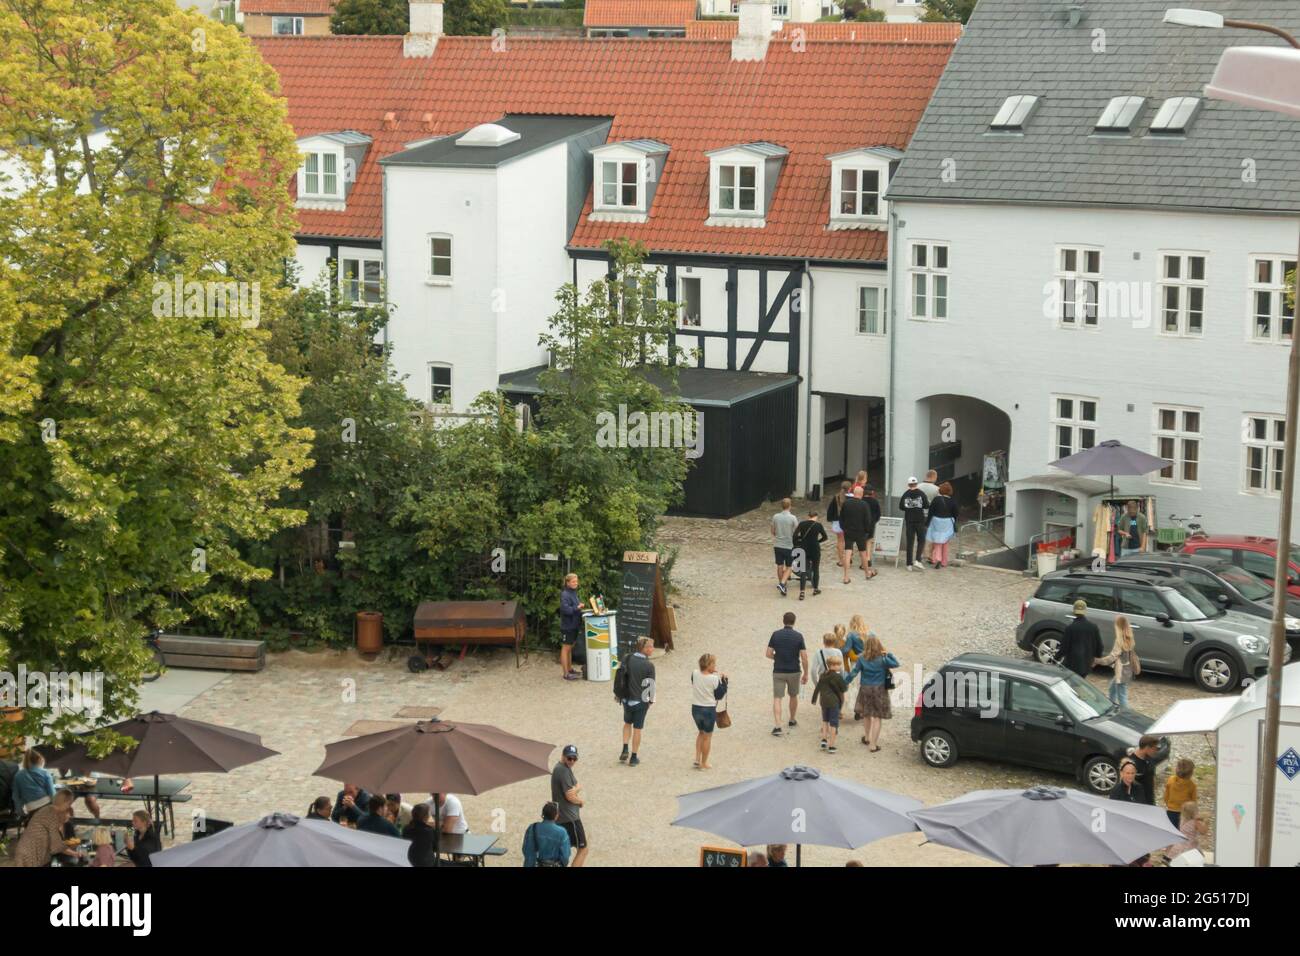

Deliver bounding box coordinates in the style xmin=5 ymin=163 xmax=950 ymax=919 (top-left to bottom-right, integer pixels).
xmin=0 ymin=0 xmax=311 ymax=744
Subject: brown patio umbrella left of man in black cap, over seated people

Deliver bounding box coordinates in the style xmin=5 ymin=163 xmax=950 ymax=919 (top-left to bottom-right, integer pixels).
xmin=313 ymin=717 xmax=555 ymax=858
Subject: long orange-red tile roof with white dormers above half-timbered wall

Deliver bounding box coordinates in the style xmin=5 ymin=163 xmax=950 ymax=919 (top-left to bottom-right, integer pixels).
xmin=254 ymin=36 xmax=952 ymax=261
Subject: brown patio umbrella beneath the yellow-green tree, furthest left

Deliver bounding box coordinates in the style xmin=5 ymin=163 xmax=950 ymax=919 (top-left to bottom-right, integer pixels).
xmin=40 ymin=710 xmax=280 ymax=822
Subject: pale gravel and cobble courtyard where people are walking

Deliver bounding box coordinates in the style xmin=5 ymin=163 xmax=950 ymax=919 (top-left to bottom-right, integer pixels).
xmin=134 ymin=511 xmax=1213 ymax=866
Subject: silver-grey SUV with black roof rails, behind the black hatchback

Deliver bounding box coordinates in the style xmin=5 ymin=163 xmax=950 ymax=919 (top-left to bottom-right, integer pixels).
xmin=1015 ymin=566 xmax=1291 ymax=693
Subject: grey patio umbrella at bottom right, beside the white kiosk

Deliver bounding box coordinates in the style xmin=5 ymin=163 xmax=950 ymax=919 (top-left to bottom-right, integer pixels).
xmin=907 ymin=787 xmax=1184 ymax=866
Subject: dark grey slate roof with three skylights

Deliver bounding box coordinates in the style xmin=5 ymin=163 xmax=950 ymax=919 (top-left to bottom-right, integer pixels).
xmin=889 ymin=0 xmax=1300 ymax=213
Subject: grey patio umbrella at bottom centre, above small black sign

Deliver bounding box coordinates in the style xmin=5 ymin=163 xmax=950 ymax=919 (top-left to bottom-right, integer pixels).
xmin=672 ymin=766 xmax=923 ymax=866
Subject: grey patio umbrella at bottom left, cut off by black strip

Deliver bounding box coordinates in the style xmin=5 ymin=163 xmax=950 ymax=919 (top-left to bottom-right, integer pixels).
xmin=150 ymin=813 xmax=411 ymax=866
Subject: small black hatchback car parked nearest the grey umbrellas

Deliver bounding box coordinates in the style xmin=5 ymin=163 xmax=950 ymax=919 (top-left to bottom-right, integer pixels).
xmin=911 ymin=654 xmax=1169 ymax=793
